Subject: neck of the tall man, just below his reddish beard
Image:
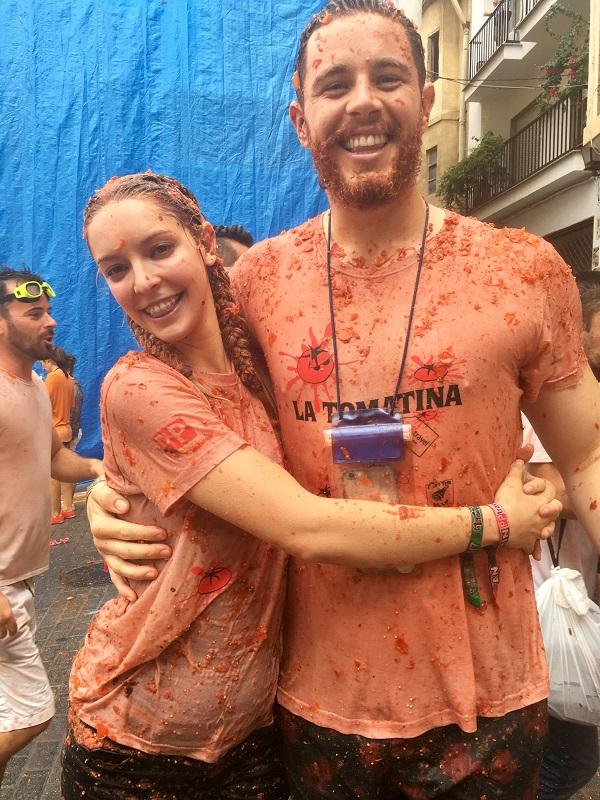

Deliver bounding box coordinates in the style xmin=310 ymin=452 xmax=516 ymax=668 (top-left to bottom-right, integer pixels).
xmin=326 ymin=186 xmax=443 ymax=261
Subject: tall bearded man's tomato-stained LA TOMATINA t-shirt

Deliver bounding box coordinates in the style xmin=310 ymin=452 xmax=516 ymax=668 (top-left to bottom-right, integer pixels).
xmin=232 ymin=213 xmax=585 ymax=738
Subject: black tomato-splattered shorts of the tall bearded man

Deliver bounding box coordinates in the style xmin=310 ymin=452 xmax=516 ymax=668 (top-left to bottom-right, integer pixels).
xmin=279 ymin=701 xmax=547 ymax=800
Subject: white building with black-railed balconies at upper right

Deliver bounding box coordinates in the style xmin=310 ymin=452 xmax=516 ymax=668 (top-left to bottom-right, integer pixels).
xmin=464 ymin=0 xmax=600 ymax=272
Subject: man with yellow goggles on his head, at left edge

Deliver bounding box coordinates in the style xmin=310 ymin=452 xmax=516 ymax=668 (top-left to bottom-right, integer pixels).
xmin=0 ymin=268 xmax=103 ymax=783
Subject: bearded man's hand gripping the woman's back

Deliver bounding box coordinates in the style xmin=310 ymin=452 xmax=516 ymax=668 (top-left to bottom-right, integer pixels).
xmin=87 ymin=481 xmax=171 ymax=601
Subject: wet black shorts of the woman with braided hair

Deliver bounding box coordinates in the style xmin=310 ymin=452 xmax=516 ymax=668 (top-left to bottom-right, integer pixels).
xmin=61 ymin=725 xmax=289 ymax=800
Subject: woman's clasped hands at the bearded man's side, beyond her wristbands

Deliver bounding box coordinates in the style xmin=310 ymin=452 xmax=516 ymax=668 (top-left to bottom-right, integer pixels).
xmin=495 ymin=459 xmax=562 ymax=559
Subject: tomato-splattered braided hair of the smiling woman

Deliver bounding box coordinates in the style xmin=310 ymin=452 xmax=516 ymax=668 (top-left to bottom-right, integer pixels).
xmin=83 ymin=172 xmax=262 ymax=392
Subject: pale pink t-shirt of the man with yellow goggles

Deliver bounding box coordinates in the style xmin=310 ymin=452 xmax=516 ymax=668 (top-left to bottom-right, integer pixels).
xmin=0 ymin=369 xmax=52 ymax=586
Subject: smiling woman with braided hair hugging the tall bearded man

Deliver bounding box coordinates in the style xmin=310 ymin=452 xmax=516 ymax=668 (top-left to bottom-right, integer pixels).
xmin=63 ymin=173 xmax=558 ymax=800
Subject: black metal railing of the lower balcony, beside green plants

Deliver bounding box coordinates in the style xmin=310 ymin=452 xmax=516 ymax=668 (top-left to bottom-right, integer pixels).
xmin=465 ymin=89 xmax=586 ymax=211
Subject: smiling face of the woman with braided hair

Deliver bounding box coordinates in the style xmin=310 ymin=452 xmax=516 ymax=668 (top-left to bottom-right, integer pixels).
xmin=87 ymin=198 xmax=215 ymax=346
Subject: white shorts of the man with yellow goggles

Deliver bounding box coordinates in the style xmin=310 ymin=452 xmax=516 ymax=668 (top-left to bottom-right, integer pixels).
xmin=0 ymin=578 xmax=54 ymax=733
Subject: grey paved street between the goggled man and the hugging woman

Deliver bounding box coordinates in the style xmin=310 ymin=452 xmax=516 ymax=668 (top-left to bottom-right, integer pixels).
xmin=0 ymin=503 xmax=600 ymax=800
